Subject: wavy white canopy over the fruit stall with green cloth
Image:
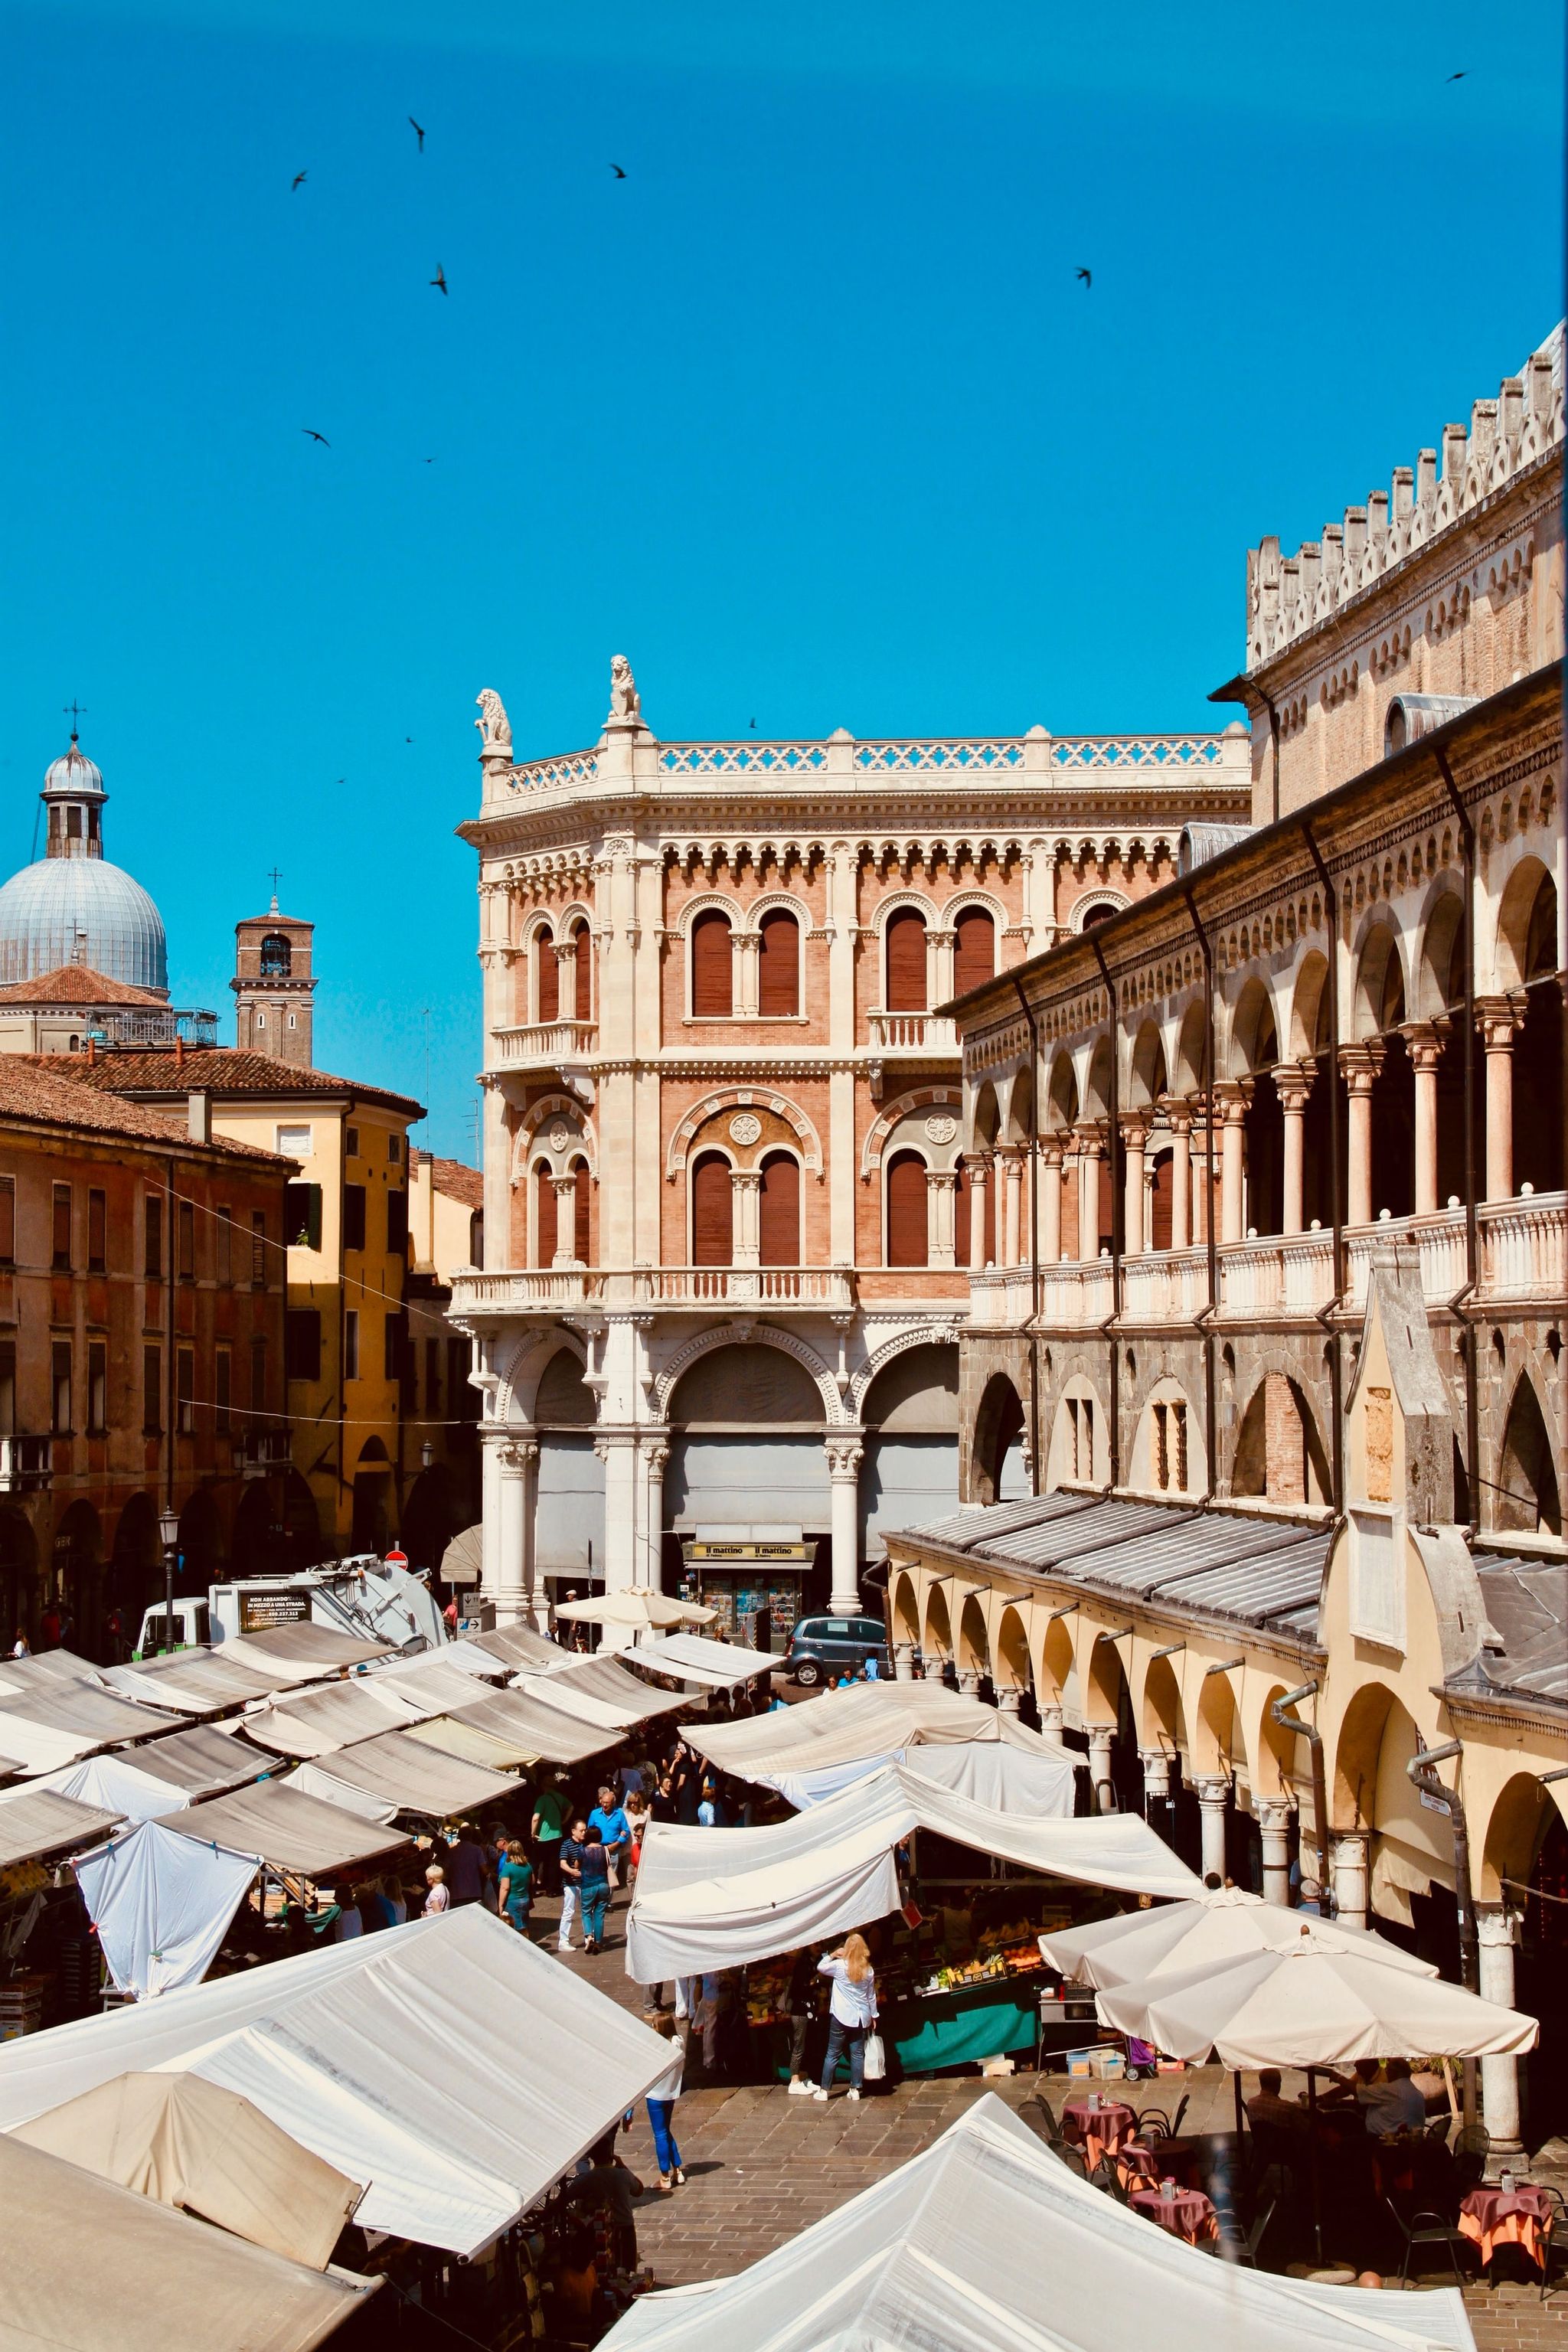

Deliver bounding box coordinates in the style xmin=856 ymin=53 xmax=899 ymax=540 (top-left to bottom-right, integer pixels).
xmin=626 ymin=1764 xmax=1199 ymax=1985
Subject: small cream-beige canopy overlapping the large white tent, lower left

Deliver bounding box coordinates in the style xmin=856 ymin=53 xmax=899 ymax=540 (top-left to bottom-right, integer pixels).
xmin=14 ymin=2075 xmax=364 ymax=2269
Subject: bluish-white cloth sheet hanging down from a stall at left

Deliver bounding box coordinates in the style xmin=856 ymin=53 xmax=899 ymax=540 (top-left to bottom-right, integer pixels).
xmin=70 ymin=1814 xmax=261 ymax=2001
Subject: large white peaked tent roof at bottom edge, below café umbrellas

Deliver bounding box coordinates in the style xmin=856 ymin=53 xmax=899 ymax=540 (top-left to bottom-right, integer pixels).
xmin=602 ymin=2093 xmax=1474 ymax=2352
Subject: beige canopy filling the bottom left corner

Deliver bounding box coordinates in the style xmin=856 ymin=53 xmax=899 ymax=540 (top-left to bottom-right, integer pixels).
xmin=0 ymin=2135 xmax=378 ymax=2352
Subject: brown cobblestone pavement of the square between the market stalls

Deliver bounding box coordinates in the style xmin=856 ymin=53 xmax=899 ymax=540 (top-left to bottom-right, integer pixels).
xmin=536 ymin=1893 xmax=1568 ymax=2352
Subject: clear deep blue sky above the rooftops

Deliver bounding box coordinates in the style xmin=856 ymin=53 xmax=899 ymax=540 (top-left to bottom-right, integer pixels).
xmin=0 ymin=0 xmax=1561 ymax=1152
